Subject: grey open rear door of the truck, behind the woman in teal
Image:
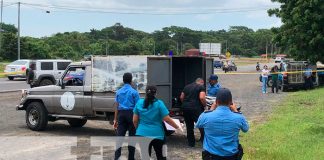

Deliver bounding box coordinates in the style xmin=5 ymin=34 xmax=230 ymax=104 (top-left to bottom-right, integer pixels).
xmin=147 ymin=57 xmax=172 ymax=109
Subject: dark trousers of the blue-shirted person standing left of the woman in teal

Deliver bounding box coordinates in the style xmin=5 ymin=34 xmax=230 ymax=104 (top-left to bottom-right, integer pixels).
xmin=115 ymin=110 xmax=136 ymax=160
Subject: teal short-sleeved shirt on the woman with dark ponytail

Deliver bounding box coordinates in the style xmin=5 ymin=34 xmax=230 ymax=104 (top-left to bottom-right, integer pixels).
xmin=133 ymin=99 xmax=169 ymax=140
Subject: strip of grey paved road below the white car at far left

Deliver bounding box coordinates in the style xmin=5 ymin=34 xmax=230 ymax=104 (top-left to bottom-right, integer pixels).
xmin=0 ymin=78 xmax=29 ymax=92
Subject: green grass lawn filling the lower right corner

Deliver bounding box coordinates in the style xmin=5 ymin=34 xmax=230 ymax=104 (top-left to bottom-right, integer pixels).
xmin=240 ymin=88 xmax=324 ymax=160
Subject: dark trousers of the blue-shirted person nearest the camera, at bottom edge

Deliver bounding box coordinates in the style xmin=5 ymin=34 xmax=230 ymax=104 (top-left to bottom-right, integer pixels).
xmin=202 ymin=144 xmax=244 ymax=160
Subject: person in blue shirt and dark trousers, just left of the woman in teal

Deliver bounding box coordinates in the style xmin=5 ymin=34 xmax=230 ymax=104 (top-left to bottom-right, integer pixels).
xmin=114 ymin=73 xmax=140 ymax=160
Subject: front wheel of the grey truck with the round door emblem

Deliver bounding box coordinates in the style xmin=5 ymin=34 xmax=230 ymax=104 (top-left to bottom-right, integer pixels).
xmin=26 ymin=102 xmax=48 ymax=131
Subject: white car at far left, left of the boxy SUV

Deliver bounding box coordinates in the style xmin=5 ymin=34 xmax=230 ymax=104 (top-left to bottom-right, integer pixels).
xmin=4 ymin=59 xmax=30 ymax=80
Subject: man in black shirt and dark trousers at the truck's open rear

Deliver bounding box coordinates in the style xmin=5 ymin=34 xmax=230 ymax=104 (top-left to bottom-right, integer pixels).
xmin=180 ymin=78 xmax=206 ymax=147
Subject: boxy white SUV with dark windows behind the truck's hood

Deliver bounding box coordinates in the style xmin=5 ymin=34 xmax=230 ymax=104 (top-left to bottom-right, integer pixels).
xmin=27 ymin=59 xmax=72 ymax=87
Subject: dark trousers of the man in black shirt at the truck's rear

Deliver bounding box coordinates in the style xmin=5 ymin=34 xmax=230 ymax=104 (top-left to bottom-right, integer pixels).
xmin=183 ymin=110 xmax=204 ymax=147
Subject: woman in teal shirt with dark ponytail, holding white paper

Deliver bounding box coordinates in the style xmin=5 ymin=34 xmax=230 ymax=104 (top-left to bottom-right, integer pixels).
xmin=133 ymin=86 xmax=181 ymax=160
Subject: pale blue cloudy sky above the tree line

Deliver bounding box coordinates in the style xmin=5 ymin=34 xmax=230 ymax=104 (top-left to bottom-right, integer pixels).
xmin=2 ymin=0 xmax=282 ymax=37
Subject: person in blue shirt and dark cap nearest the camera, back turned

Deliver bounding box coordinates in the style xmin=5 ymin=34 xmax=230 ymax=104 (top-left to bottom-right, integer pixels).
xmin=196 ymin=88 xmax=249 ymax=160
